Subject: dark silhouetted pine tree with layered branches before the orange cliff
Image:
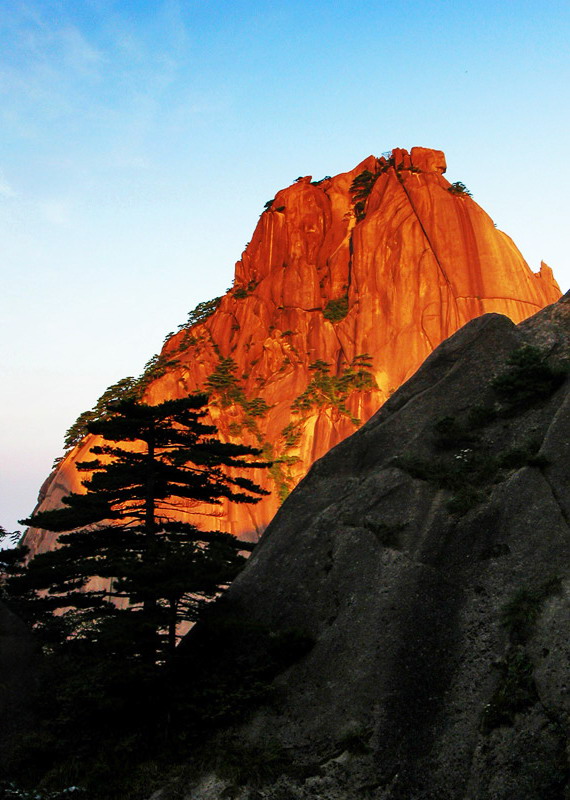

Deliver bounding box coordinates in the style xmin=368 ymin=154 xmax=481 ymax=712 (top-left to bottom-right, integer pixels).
xmin=8 ymin=395 xmax=267 ymax=664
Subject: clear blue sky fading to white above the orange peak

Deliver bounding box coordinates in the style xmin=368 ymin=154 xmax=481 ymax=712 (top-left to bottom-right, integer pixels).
xmin=0 ymin=0 xmax=570 ymax=530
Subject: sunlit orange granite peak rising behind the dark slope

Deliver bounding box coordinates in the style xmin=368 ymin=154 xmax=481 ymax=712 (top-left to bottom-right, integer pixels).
xmin=27 ymin=147 xmax=560 ymax=551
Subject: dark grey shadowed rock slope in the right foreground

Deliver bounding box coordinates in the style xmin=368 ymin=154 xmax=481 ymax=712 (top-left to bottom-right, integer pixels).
xmin=170 ymin=296 xmax=570 ymax=800
